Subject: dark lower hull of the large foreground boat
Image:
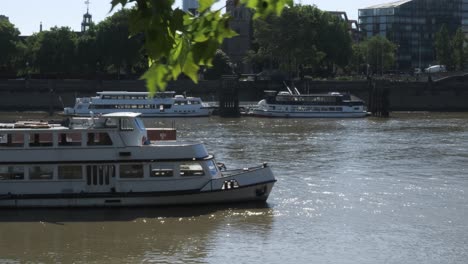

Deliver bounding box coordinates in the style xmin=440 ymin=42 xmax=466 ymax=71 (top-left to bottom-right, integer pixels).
xmin=0 ymin=180 xmax=276 ymax=208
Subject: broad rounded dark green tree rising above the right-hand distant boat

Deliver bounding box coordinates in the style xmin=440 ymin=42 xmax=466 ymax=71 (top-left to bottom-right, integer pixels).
xmin=249 ymin=5 xmax=352 ymax=77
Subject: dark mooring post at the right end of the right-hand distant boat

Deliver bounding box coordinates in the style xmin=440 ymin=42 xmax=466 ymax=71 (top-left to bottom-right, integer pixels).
xmin=368 ymin=80 xmax=390 ymax=117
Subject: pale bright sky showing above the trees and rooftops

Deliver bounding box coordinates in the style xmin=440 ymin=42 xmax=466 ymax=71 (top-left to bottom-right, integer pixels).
xmin=0 ymin=0 xmax=380 ymax=35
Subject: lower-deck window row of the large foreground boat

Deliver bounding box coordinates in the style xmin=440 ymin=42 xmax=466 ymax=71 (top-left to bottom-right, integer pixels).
xmin=0 ymin=161 xmax=217 ymax=182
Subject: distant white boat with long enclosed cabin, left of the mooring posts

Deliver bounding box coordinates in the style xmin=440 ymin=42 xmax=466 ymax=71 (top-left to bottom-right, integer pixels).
xmin=64 ymin=91 xmax=212 ymax=117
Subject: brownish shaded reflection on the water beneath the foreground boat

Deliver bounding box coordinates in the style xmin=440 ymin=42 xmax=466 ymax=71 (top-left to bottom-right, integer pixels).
xmin=0 ymin=203 xmax=273 ymax=263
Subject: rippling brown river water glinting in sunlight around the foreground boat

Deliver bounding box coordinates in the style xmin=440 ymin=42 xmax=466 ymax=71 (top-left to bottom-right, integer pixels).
xmin=0 ymin=113 xmax=468 ymax=264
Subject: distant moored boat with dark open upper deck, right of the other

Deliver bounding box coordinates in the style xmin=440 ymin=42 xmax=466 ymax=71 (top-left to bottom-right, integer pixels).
xmin=252 ymin=88 xmax=367 ymax=118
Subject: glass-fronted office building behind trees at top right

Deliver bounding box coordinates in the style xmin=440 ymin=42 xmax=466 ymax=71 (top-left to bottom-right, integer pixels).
xmin=359 ymin=0 xmax=468 ymax=70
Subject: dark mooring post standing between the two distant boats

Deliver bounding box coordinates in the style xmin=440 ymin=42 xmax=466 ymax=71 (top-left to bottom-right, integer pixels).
xmin=218 ymin=75 xmax=240 ymax=117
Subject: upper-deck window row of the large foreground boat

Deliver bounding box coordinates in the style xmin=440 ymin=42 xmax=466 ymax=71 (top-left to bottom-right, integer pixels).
xmin=0 ymin=132 xmax=113 ymax=148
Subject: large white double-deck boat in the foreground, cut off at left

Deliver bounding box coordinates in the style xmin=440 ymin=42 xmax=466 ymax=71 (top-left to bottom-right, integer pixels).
xmin=0 ymin=112 xmax=276 ymax=207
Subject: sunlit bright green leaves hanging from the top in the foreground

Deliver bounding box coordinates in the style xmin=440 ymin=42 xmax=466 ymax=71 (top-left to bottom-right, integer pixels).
xmin=112 ymin=0 xmax=293 ymax=92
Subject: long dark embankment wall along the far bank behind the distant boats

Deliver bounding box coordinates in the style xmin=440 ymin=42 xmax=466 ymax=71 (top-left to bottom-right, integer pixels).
xmin=0 ymin=75 xmax=468 ymax=111
